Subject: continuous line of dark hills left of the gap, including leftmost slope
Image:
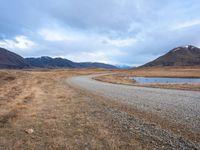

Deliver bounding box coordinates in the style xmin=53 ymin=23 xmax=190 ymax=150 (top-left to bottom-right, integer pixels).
xmin=0 ymin=48 xmax=117 ymax=69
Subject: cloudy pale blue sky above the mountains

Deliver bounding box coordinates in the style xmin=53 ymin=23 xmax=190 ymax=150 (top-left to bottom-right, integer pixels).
xmin=0 ymin=0 xmax=200 ymax=66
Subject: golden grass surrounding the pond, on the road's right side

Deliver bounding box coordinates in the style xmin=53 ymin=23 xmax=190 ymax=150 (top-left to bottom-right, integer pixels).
xmin=95 ymin=67 xmax=200 ymax=91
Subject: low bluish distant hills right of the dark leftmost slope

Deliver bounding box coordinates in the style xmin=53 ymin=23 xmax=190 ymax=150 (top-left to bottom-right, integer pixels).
xmin=26 ymin=56 xmax=117 ymax=69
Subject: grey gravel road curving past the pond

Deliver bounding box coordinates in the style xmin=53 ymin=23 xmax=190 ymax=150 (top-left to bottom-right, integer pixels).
xmin=67 ymin=75 xmax=200 ymax=131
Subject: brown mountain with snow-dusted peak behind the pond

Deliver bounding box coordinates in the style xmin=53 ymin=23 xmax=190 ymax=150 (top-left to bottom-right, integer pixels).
xmin=143 ymin=45 xmax=200 ymax=67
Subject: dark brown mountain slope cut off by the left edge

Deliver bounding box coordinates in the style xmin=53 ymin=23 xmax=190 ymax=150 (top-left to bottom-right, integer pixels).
xmin=0 ymin=48 xmax=30 ymax=69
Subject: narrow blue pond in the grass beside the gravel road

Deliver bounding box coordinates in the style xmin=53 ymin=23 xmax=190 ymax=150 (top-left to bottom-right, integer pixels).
xmin=127 ymin=77 xmax=200 ymax=84
